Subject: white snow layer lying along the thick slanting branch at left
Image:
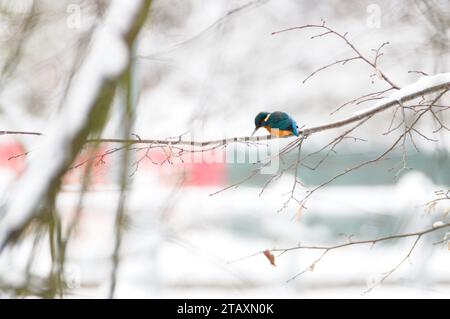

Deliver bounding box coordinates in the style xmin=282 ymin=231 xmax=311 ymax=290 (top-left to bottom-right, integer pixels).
xmin=0 ymin=0 xmax=142 ymax=250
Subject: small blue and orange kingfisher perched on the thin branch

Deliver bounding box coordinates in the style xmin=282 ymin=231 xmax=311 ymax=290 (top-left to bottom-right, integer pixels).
xmin=252 ymin=111 xmax=300 ymax=137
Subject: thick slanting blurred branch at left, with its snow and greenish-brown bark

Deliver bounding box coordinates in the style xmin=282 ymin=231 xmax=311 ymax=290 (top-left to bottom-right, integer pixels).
xmin=0 ymin=0 xmax=151 ymax=250
